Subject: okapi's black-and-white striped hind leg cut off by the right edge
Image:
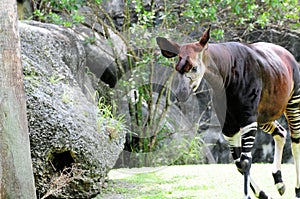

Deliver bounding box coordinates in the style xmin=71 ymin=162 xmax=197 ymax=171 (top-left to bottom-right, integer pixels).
xmin=286 ymin=94 xmax=300 ymax=198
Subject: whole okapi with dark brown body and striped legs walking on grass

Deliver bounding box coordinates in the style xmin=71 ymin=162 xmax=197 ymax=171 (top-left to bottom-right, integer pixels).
xmin=156 ymin=27 xmax=300 ymax=199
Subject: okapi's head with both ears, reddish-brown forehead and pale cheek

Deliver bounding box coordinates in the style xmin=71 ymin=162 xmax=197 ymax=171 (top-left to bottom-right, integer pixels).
xmin=156 ymin=27 xmax=210 ymax=102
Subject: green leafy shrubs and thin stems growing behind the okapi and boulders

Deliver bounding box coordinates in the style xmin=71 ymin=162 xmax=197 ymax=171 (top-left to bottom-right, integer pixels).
xmin=27 ymin=0 xmax=300 ymax=166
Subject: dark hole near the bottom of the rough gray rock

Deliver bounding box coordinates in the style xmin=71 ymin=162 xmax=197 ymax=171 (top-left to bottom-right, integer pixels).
xmin=52 ymin=151 xmax=75 ymax=172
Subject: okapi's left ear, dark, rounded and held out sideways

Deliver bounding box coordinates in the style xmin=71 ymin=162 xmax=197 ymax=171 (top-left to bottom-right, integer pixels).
xmin=156 ymin=37 xmax=180 ymax=58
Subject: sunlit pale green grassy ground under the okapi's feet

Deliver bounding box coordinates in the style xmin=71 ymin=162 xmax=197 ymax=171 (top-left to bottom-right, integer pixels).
xmin=97 ymin=164 xmax=296 ymax=199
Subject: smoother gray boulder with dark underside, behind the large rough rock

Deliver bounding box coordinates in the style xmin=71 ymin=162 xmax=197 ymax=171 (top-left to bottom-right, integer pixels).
xmin=76 ymin=21 xmax=128 ymax=87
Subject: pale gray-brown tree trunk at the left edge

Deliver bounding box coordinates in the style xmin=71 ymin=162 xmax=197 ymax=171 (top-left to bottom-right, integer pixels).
xmin=0 ymin=0 xmax=36 ymax=199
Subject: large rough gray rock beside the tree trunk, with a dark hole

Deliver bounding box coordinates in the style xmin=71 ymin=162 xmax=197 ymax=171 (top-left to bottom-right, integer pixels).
xmin=19 ymin=22 xmax=126 ymax=198
